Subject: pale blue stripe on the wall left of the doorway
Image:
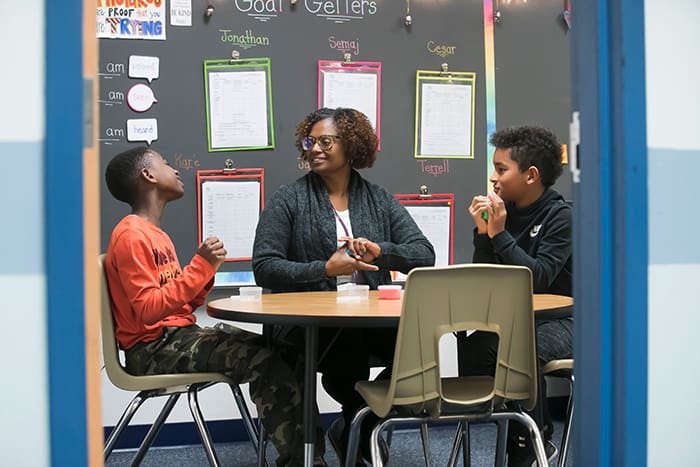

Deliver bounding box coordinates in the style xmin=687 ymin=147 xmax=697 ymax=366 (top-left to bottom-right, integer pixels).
xmin=0 ymin=141 xmax=44 ymax=275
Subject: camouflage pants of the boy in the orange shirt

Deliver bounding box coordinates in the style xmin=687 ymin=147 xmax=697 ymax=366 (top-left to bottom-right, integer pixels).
xmin=126 ymin=323 xmax=324 ymax=466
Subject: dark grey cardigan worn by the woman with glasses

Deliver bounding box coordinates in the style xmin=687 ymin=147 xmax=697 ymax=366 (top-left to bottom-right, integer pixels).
xmin=253 ymin=170 xmax=435 ymax=292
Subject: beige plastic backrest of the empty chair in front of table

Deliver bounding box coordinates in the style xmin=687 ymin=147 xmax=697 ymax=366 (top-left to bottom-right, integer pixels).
xmin=389 ymin=264 xmax=537 ymax=416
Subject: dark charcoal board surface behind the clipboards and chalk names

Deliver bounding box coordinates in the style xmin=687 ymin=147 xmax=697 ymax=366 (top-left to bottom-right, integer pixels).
xmin=100 ymin=0 xmax=569 ymax=270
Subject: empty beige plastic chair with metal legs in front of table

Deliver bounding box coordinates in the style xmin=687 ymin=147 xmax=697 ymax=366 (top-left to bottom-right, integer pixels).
xmin=346 ymin=264 xmax=547 ymax=467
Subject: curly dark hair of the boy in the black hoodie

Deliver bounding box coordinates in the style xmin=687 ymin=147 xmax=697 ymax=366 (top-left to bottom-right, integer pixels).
xmin=491 ymin=126 xmax=562 ymax=187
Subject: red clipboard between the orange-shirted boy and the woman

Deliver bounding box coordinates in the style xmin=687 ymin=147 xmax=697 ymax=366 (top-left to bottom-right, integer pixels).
xmin=197 ymin=168 xmax=265 ymax=261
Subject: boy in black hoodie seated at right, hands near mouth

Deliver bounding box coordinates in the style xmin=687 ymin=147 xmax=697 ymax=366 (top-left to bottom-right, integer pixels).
xmin=459 ymin=126 xmax=573 ymax=467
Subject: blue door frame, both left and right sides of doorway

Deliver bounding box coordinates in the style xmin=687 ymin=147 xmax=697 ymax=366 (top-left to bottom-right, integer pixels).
xmin=44 ymin=0 xmax=648 ymax=466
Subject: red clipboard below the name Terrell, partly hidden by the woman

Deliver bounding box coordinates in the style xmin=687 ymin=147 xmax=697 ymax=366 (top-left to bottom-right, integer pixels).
xmin=392 ymin=191 xmax=455 ymax=280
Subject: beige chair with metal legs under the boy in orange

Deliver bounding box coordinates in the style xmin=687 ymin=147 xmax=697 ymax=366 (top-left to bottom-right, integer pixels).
xmin=98 ymin=254 xmax=263 ymax=466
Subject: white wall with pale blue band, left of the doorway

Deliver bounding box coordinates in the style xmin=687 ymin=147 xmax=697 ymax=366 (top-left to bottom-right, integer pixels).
xmin=0 ymin=0 xmax=49 ymax=467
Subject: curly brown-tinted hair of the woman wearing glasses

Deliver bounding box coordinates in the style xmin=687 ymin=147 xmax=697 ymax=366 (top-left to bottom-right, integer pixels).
xmin=296 ymin=107 xmax=378 ymax=169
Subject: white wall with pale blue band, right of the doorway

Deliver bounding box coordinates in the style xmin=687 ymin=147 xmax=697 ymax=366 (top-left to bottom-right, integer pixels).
xmin=644 ymin=0 xmax=700 ymax=466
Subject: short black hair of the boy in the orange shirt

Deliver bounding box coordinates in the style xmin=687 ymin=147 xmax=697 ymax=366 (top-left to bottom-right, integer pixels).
xmin=105 ymin=146 xmax=155 ymax=206
